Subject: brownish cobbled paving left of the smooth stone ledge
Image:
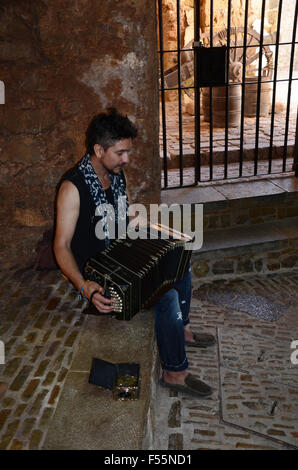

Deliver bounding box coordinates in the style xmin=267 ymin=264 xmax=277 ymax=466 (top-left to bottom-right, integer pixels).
xmin=0 ymin=270 xmax=85 ymax=450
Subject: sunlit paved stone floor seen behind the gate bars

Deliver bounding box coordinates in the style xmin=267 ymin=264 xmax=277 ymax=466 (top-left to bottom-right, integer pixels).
xmin=160 ymin=102 xmax=297 ymax=188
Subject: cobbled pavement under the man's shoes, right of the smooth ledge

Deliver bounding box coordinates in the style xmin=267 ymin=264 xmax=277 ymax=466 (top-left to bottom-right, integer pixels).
xmin=153 ymin=271 xmax=298 ymax=450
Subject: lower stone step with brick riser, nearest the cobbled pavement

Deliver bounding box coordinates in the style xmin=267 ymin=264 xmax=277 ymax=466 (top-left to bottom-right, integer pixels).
xmin=192 ymin=217 xmax=298 ymax=281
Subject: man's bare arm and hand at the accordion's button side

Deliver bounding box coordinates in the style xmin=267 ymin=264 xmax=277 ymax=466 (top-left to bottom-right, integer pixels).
xmin=54 ymin=181 xmax=113 ymax=313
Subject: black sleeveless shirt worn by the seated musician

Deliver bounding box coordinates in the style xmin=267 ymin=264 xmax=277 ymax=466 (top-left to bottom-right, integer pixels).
xmin=64 ymin=168 xmax=125 ymax=273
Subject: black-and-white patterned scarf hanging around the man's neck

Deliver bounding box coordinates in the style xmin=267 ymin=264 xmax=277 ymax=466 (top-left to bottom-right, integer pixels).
xmin=78 ymin=153 xmax=129 ymax=247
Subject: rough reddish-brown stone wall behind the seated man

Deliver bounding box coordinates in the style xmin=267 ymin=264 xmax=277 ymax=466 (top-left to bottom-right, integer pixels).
xmin=0 ymin=0 xmax=160 ymax=267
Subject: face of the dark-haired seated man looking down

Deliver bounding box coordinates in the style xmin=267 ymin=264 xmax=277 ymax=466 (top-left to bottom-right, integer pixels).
xmin=101 ymin=138 xmax=132 ymax=174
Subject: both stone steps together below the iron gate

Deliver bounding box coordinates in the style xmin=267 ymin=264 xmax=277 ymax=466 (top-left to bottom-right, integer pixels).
xmin=162 ymin=176 xmax=298 ymax=280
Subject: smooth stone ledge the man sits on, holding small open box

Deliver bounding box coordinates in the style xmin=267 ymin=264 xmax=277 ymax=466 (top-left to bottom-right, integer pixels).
xmin=43 ymin=311 xmax=156 ymax=450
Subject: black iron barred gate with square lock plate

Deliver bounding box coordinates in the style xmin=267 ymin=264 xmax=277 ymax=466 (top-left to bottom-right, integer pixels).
xmin=157 ymin=0 xmax=298 ymax=189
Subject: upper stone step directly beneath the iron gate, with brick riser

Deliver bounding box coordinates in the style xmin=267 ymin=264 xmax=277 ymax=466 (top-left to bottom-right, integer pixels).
xmin=161 ymin=176 xmax=298 ymax=230
